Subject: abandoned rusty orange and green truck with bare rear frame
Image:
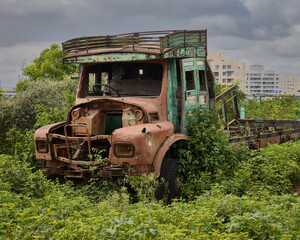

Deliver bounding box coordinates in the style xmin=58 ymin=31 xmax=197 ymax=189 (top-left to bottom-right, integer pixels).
xmin=34 ymin=30 xmax=300 ymax=198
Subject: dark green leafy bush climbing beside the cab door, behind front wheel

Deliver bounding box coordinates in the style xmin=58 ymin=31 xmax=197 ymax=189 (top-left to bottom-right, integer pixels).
xmin=178 ymin=110 xmax=247 ymax=199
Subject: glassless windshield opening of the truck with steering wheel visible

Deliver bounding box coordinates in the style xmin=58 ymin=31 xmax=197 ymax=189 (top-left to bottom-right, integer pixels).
xmin=77 ymin=61 xmax=165 ymax=99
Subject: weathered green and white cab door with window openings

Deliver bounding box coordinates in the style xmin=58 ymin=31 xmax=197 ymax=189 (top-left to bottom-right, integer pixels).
xmin=180 ymin=58 xmax=209 ymax=134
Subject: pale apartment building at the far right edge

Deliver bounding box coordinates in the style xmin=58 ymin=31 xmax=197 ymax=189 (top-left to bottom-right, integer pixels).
xmin=279 ymin=74 xmax=300 ymax=95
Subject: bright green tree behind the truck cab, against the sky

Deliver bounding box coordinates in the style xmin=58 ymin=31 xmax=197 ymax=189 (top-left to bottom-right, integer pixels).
xmin=23 ymin=44 xmax=77 ymax=81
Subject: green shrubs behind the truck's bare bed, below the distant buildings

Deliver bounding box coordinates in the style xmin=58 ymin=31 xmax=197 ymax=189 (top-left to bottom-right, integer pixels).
xmin=242 ymin=97 xmax=300 ymax=119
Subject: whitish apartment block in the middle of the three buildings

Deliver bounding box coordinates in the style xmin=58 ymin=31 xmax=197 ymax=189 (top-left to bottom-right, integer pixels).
xmin=245 ymin=64 xmax=279 ymax=96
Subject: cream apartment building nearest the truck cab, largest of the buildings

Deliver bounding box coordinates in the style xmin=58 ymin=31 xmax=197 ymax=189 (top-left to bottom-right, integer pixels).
xmin=208 ymin=52 xmax=246 ymax=92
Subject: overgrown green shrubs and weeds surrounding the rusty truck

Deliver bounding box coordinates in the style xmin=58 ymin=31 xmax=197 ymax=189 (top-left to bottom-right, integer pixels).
xmin=0 ymin=45 xmax=300 ymax=239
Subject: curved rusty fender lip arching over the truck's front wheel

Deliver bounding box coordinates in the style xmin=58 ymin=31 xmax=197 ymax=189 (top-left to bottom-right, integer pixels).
xmin=153 ymin=133 xmax=188 ymax=177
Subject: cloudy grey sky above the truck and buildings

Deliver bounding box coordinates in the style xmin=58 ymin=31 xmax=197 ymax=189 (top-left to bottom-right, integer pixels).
xmin=0 ymin=0 xmax=300 ymax=88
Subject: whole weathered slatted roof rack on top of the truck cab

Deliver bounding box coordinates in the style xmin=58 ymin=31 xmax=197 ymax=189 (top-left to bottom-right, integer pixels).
xmin=62 ymin=29 xmax=207 ymax=63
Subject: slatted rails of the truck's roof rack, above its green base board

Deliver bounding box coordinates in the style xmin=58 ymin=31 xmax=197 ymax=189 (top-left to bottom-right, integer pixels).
xmin=62 ymin=30 xmax=206 ymax=62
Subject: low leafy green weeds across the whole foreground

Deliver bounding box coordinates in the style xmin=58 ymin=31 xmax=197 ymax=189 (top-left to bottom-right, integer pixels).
xmin=0 ymin=156 xmax=300 ymax=239
